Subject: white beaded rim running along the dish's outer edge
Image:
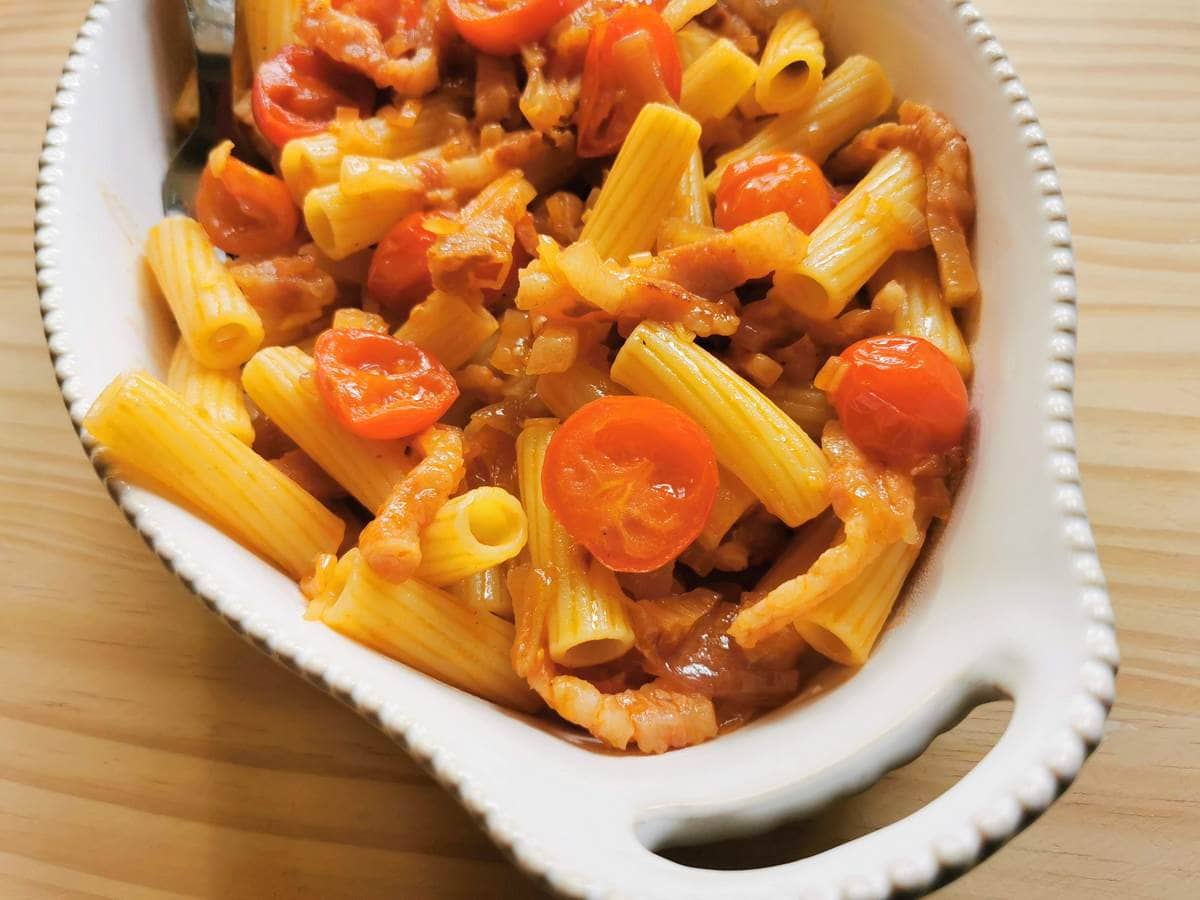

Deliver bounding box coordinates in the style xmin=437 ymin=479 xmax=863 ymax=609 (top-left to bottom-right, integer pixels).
xmin=34 ymin=0 xmax=1120 ymax=898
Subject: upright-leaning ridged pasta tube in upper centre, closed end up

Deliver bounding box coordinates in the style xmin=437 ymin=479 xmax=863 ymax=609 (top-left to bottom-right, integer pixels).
xmin=581 ymin=103 xmax=700 ymax=263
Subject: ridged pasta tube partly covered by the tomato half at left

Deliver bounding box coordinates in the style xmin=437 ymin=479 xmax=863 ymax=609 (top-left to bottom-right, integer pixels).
xmin=241 ymin=347 xmax=413 ymax=512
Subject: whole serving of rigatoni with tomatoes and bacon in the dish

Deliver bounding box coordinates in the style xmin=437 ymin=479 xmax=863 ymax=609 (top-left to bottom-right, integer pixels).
xmin=85 ymin=0 xmax=988 ymax=752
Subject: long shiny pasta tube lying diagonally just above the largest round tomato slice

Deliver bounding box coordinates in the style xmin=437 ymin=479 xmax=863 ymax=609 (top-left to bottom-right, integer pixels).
xmin=612 ymin=322 xmax=829 ymax=528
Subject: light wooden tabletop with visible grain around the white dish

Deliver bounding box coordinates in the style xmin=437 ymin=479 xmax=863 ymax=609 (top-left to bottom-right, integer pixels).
xmin=0 ymin=0 xmax=1200 ymax=900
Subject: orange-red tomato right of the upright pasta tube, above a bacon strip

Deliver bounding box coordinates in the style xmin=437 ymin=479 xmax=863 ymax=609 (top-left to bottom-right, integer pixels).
xmin=714 ymin=154 xmax=834 ymax=234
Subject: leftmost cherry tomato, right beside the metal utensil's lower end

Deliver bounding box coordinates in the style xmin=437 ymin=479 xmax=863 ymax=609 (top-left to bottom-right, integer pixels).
xmin=196 ymin=140 xmax=300 ymax=256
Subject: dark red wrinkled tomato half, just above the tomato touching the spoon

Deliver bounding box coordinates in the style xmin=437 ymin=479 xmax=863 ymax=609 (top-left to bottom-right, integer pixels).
xmin=251 ymin=44 xmax=376 ymax=146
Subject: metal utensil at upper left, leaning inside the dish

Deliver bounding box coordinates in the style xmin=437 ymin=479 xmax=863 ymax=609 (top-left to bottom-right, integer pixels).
xmin=162 ymin=0 xmax=235 ymax=214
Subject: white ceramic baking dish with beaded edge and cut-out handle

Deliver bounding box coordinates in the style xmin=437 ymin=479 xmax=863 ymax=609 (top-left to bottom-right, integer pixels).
xmin=36 ymin=0 xmax=1117 ymax=899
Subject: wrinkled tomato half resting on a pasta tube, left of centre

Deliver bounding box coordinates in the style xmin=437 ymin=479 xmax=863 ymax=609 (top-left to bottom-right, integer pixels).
xmin=313 ymin=329 xmax=458 ymax=440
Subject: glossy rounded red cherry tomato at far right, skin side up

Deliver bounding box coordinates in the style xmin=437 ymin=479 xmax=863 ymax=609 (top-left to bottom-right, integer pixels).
xmin=830 ymin=335 xmax=967 ymax=466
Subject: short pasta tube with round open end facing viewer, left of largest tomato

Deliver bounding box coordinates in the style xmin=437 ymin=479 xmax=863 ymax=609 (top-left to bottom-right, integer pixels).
xmin=416 ymin=486 xmax=528 ymax=587
